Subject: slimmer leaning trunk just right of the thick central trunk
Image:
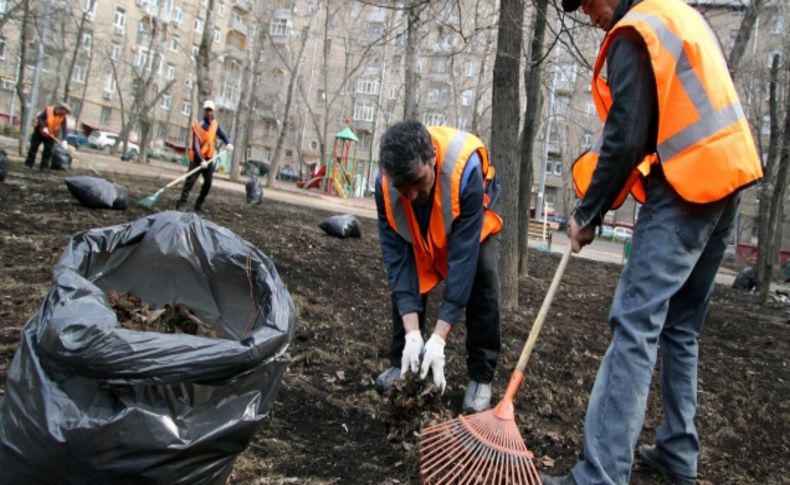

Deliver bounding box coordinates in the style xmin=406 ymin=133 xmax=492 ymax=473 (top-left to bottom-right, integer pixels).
xmin=518 ymin=0 xmax=549 ymax=276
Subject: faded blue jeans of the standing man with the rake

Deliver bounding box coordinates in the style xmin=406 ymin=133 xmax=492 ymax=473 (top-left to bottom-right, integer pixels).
xmin=572 ymin=172 xmax=739 ymax=485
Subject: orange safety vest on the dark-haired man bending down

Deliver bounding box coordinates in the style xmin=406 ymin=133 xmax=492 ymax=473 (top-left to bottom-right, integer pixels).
xmin=381 ymin=126 xmax=502 ymax=294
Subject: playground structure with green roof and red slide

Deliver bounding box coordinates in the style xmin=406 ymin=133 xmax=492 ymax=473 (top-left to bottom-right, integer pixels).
xmin=296 ymin=122 xmax=372 ymax=198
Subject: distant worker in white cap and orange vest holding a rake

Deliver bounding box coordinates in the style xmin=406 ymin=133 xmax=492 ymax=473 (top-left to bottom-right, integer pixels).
xmin=176 ymin=99 xmax=233 ymax=212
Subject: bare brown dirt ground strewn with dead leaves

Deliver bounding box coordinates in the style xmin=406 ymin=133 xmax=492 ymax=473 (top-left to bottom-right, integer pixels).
xmin=0 ymin=163 xmax=790 ymax=484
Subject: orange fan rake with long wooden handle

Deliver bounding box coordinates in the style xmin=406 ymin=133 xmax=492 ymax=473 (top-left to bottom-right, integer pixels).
xmin=420 ymin=246 xmax=571 ymax=485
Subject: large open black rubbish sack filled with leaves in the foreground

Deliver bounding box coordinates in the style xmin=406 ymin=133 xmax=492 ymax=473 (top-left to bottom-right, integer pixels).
xmin=0 ymin=211 xmax=295 ymax=485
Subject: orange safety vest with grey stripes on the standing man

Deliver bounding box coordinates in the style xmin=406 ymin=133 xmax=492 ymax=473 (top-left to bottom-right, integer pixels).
xmin=574 ymin=0 xmax=762 ymax=203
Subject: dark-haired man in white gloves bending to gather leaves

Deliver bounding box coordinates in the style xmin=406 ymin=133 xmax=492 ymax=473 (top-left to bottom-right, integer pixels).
xmin=375 ymin=121 xmax=502 ymax=412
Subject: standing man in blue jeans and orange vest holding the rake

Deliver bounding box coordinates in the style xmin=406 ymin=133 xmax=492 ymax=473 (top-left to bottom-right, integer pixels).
xmin=542 ymin=0 xmax=762 ymax=485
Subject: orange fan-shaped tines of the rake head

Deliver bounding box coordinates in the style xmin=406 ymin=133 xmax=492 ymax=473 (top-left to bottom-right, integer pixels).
xmin=420 ymin=400 xmax=540 ymax=485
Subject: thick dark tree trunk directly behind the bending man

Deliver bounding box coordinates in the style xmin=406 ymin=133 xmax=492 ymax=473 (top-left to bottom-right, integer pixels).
xmin=491 ymin=0 xmax=524 ymax=309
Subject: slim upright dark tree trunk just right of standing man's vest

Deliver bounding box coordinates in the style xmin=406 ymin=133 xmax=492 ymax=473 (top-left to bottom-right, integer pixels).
xmin=757 ymin=56 xmax=781 ymax=301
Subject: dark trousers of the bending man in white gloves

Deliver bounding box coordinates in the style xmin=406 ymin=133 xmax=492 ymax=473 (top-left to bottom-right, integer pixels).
xmin=389 ymin=234 xmax=502 ymax=384
